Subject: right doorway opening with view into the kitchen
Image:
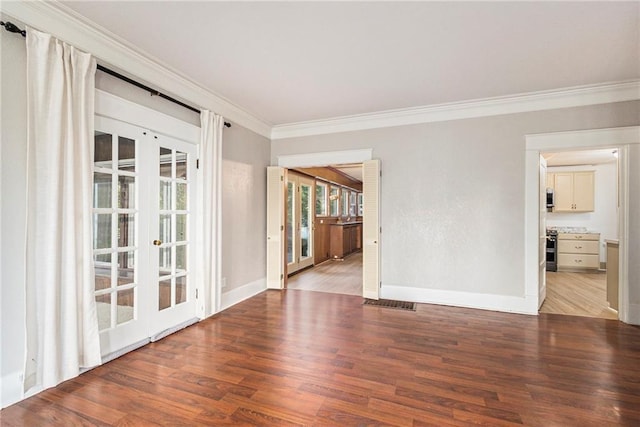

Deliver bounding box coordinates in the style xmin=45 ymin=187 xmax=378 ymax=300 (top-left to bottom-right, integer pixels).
xmin=540 ymin=148 xmax=620 ymax=320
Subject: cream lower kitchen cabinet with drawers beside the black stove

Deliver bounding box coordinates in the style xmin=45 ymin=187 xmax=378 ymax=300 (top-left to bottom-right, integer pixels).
xmin=558 ymin=233 xmax=600 ymax=270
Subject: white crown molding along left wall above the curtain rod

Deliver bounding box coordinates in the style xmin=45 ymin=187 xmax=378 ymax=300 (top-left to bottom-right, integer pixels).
xmin=0 ymin=0 xmax=271 ymax=138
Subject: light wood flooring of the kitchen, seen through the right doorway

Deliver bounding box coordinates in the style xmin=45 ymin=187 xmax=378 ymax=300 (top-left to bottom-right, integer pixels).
xmin=540 ymin=271 xmax=618 ymax=319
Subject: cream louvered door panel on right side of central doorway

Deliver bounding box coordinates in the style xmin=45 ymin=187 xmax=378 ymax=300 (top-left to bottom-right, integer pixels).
xmin=362 ymin=160 xmax=380 ymax=299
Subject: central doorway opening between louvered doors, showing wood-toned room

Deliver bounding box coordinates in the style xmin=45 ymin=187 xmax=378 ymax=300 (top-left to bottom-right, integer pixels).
xmin=285 ymin=163 xmax=364 ymax=295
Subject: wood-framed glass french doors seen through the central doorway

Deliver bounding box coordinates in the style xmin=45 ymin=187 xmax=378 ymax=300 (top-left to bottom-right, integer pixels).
xmin=285 ymin=173 xmax=315 ymax=274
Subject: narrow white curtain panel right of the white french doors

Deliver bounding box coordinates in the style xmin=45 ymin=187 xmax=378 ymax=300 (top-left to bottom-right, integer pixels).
xmin=198 ymin=110 xmax=224 ymax=316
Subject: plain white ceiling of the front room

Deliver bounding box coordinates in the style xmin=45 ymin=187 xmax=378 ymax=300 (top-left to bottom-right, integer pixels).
xmin=64 ymin=1 xmax=640 ymax=125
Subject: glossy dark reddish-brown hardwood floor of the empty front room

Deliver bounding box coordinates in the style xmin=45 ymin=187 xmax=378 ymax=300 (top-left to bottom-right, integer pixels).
xmin=0 ymin=291 xmax=640 ymax=427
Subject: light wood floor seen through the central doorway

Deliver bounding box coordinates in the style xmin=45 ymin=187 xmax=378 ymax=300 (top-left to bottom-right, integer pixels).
xmin=287 ymin=252 xmax=362 ymax=295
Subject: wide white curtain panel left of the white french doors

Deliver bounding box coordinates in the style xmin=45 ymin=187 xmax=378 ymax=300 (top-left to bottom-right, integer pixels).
xmin=24 ymin=28 xmax=100 ymax=390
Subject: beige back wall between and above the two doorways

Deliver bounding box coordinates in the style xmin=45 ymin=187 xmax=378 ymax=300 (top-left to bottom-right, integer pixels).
xmin=271 ymin=102 xmax=640 ymax=305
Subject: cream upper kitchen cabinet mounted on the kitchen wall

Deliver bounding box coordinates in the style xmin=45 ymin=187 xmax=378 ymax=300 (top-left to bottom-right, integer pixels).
xmin=548 ymin=171 xmax=595 ymax=212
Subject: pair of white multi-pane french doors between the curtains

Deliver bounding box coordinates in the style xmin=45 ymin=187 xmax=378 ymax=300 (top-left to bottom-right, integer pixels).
xmin=93 ymin=116 xmax=196 ymax=356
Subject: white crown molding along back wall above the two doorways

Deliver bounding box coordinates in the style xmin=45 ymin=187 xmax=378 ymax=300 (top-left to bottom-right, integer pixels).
xmin=271 ymin=80 xmax=640 ymax=140
